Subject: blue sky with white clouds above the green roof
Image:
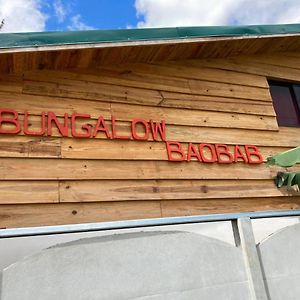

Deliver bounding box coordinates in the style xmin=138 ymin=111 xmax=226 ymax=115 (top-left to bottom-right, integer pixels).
xmin=0 ymin=0 xmax=300 ymax=32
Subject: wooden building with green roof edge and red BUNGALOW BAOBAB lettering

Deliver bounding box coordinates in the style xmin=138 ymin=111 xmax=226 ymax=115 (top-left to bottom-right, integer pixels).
xmin=0 ymin=25 xmax=300 ymax=228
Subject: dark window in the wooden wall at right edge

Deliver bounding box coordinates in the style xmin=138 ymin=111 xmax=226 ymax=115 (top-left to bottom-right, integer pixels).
xmin=269 ymin=81 xmax=300 ymax=127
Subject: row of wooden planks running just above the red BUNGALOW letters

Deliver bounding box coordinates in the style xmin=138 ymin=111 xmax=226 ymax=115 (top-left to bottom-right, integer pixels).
xmin=0 ymin=92 xmax=278 ymax=130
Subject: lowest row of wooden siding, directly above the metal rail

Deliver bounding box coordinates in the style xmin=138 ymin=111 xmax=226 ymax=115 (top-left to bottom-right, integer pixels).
xmin=0 ymin=197 xmax=300 ymax=228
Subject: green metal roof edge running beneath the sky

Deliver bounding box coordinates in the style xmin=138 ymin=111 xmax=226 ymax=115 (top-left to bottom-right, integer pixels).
xmin=0 ymin=24 xmax=300 ymax=48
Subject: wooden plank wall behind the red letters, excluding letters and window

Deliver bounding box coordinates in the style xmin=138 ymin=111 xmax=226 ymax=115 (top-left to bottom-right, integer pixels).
xmin=0 ymin=52 xmax=300 ymax=228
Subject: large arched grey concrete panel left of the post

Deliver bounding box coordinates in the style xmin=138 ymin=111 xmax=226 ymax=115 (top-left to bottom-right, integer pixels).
xmin=0 ymin=232 xmax=250 ymax=300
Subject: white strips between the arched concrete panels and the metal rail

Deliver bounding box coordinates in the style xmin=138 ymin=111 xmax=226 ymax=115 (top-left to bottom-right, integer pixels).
xmin=0 ymin=217 xmax=299 ymax=271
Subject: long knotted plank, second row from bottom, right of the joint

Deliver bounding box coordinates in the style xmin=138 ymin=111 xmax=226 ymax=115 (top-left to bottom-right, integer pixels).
xmin=60 ymin=180 xmax=288 ymax=202
